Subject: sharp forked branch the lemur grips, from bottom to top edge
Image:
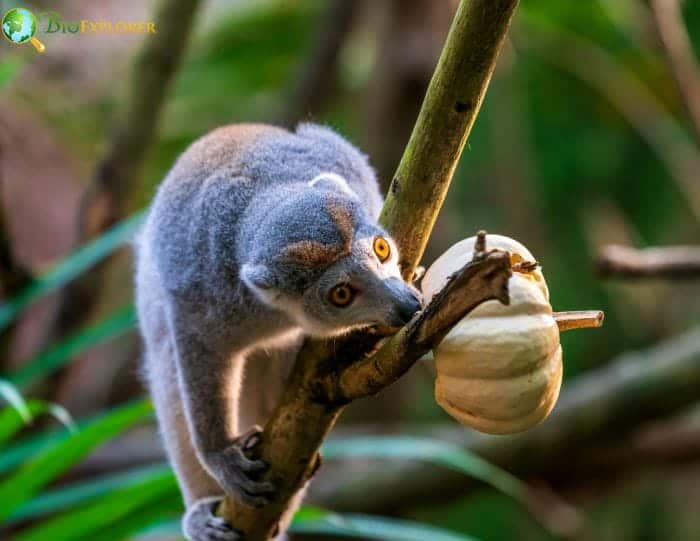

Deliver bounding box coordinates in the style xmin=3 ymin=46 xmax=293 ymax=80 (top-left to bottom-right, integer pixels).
xmin=220 ymin=0 xmax=518 ymax=541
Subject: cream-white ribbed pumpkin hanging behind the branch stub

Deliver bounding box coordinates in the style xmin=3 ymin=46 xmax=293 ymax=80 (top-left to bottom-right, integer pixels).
xmin=422 ymin=235 xmax=562 ymax=434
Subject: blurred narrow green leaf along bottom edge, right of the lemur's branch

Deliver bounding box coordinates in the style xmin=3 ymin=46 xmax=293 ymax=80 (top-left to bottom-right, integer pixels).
xmin=291 ymin=507 xmax=482 ymax=541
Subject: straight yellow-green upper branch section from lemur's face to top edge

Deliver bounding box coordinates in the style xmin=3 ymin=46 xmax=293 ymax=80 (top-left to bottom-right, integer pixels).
xmin=380 ymin=0 xmax=518 ymax=279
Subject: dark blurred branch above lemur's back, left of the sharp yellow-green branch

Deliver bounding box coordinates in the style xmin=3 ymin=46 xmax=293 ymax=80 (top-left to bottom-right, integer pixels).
xmin=284 ymin=0 xmax=363 ymax=127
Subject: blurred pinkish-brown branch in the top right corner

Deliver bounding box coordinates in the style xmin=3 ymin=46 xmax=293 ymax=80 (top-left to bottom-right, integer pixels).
xmin=649 ymin=0 xmax=700 ymax=144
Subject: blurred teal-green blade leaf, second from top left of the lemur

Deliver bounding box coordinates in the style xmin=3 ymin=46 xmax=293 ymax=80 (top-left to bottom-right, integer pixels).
xmin=9 ymin=305 xmax=136 ymax=387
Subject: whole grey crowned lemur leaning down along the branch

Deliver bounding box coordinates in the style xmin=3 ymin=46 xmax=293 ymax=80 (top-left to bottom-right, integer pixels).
xmin=136 ymin=124 xmax=420 ymax=541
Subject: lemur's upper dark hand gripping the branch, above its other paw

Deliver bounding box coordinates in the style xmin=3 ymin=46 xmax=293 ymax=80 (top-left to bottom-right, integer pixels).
xmin=209 ymin=426 xmax=276 ymax=507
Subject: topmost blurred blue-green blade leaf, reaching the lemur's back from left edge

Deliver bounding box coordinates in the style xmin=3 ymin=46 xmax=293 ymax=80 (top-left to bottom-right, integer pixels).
xmin=0 ymin=212 xmax=145 ymax=330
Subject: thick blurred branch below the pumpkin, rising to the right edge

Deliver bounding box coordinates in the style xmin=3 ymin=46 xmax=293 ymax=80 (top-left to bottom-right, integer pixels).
xmin=312 ymin=328 xmax=700 ymax=512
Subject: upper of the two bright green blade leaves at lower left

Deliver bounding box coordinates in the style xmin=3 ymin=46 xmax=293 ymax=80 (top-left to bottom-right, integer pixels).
xmin=0 ymin=400 xmax=153 ymax=521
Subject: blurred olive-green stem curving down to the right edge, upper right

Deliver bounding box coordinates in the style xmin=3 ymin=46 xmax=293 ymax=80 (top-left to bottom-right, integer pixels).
xmin=514 ymin=11 xmax=700 ymax=222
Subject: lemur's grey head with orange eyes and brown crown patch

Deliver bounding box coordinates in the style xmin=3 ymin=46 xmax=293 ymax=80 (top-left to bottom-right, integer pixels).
xmin=241 ymin=174 xmax=421 ymax=336
